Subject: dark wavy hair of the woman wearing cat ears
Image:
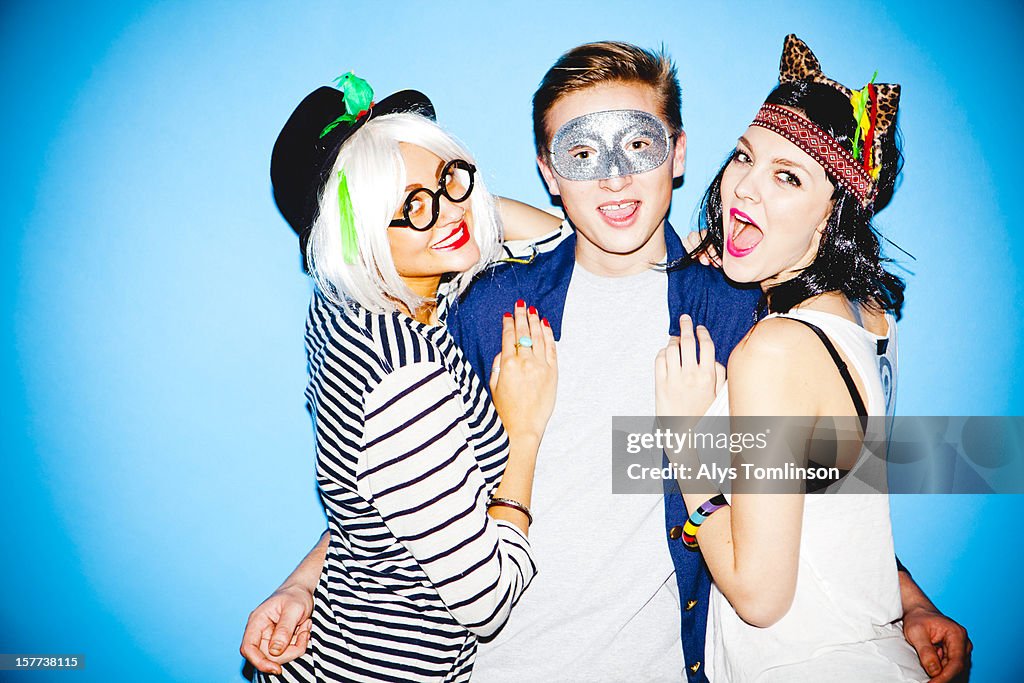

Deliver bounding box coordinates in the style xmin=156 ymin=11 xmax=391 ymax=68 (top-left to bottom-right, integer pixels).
xmin=699 ymin=81 xmax=906 ymax=318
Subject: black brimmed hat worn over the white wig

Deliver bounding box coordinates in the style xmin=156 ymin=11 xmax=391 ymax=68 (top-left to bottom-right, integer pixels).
xmin=270 ymin=78 xmax=434 ymax=253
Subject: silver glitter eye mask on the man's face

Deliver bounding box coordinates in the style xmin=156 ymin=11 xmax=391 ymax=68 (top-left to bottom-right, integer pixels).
xmin=551 ymin=110 xmax=672 ymax=180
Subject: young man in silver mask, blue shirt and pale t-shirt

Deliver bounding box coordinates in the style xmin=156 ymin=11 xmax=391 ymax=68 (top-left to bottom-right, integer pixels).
xmin=449 ymin=42 xmax=970 ymax=683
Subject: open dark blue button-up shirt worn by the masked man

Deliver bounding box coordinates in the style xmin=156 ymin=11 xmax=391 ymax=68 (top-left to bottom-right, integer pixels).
xmin=447 ymin=227 xmax=761 ymax=683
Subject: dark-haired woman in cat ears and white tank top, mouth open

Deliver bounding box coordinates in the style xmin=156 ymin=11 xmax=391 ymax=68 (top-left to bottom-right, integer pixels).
xmin=656 ymin=36 xmax=929 ymax=683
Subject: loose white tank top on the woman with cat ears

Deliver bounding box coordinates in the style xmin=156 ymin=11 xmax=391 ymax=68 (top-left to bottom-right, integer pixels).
xmin=706 ymin=310 xmax=928 ymax=683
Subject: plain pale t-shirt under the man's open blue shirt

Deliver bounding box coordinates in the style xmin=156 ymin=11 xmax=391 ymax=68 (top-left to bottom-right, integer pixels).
xmin=473 ymin=265 xmax=685 ymax=683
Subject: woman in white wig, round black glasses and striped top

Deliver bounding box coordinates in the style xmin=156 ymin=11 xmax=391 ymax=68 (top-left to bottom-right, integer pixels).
xmin=242 ymin=74 xmax=556 ymax=681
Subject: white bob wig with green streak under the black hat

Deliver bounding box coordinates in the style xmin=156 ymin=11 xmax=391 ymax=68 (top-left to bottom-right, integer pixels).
xmin=306 ymin=114 xmax=502 ymax=313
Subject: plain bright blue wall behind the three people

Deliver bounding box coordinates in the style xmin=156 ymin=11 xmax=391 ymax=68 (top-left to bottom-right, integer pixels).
xmin=0 ymin=1 xmax=1024 ymax=681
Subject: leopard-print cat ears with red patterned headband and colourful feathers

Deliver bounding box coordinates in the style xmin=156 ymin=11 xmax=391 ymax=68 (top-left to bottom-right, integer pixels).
xmin=753 ymin=34 xmax=900 ymax=206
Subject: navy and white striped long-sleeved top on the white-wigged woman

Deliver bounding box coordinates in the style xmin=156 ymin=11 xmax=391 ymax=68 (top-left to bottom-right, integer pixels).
xmin=266 ymin=294 xmax=537 ymax=681
